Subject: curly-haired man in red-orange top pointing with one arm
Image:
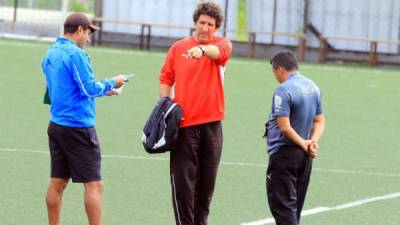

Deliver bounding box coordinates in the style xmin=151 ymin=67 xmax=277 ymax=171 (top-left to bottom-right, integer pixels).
xmin=159 ymin=1 xmax=232 ymax=225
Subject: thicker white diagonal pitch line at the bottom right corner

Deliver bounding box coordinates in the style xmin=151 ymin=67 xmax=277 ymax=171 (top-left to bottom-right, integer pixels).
xmin=240 ymin=192 xmax=400 ymax=225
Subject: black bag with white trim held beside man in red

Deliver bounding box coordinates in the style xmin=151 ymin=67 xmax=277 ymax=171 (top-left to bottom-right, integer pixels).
xmin=142 ymin=97 xmax=183 ymax=154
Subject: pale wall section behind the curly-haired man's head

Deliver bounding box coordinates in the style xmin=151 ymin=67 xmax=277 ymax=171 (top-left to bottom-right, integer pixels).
xmin=103 ymin=0 xmax=237 ymax=38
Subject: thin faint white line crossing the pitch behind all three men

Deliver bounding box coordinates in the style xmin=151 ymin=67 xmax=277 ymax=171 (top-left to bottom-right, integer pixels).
xmin=0 ymin=147 xmax=400 ymax=177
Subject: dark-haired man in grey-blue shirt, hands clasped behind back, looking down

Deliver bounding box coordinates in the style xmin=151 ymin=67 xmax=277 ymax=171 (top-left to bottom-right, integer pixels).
xmin=265 ymin=51 xmax=325 ymax=225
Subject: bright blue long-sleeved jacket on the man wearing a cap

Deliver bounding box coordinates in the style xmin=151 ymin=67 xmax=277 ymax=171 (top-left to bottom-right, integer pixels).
xmin=42 ymin=37 xmax=116 ymax=127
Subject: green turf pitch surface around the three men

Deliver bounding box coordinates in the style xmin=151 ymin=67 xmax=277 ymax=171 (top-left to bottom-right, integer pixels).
xmin=0 ymin=40 xmax=400 ymax=225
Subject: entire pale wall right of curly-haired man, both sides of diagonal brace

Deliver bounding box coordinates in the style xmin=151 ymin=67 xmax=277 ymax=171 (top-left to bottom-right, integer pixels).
xmin=247 ymin=0 xmax=400 ymax=53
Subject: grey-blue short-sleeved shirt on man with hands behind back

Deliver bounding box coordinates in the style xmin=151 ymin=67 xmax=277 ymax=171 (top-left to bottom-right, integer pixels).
xmin=267 ymin=72 xmax=322 ymax=155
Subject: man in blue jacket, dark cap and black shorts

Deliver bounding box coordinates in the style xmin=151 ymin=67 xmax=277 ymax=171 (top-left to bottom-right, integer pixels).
xmin=42 ymin=13 xmax=124 ymax=225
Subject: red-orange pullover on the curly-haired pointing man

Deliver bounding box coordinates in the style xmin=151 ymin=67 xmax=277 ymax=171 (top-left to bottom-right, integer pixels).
xmin=159 ymin=36 xmax=232 ymax=127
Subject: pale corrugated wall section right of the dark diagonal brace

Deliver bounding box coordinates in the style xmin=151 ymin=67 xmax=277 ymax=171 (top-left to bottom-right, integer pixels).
xmin=310 ymin=0 xmax=400 ymax=53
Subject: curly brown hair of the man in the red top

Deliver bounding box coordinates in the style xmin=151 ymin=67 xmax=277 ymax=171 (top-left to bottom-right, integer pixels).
xmin=193 ymin=1 xmax=224 ymax=28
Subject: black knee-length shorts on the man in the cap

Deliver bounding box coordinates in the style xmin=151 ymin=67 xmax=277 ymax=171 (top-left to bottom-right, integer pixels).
xmin=47 ymin=122 xmax=101 ymax=183
